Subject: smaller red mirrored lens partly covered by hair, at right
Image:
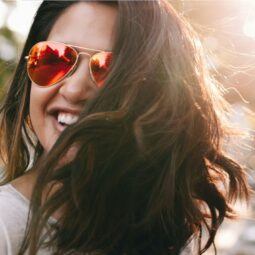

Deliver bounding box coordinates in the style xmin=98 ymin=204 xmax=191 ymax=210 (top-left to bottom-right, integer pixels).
xmin=90 ymin=52 xmax=112 ymax=87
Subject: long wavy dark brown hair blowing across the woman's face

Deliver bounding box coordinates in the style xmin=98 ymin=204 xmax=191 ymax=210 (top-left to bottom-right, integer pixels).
xmin=1 ymin=0 xmax=248 ymax=255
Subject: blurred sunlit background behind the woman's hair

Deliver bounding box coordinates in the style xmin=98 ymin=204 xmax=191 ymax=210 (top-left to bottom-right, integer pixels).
xmin=0 ymin=0 xmax=255 ymax=255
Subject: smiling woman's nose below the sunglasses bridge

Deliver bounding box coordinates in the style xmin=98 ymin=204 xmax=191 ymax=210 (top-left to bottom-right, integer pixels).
xmin=58 ymin=56 xmax=97 ymax=104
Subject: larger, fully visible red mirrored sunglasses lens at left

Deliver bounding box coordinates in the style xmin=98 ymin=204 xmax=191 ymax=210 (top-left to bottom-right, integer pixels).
xmin=27 ymin=42 xmax=77 ymax=86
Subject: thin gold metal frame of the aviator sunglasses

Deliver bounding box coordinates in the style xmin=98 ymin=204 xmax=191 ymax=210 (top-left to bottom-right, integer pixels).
xmin=25 ymin=41 xmax=112 ymax=88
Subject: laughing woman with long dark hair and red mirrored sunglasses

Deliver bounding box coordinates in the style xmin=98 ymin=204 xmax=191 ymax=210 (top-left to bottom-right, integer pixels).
xmin=0 ymin=0 xmax=248 ymax=255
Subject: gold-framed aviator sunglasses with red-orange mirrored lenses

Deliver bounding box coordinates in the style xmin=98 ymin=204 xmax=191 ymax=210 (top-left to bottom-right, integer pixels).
xmin=25 ymin=41 xmax=112 ymax=87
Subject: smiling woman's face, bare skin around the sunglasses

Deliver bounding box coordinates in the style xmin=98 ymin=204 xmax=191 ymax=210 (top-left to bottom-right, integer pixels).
xmin=30 ymin=2 xmax=117 ymax=152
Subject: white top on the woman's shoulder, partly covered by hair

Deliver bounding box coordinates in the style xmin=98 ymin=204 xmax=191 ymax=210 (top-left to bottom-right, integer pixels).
xmin=0 ymin=183 xmax=193 ymax=255
